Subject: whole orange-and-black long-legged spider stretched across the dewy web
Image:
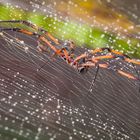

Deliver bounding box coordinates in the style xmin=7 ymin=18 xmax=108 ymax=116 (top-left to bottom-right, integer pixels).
xmin=0 ymin=20 xmax=140 ymax=92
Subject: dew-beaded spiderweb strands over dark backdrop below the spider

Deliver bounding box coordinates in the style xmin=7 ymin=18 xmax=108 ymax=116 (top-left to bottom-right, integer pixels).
xmin=0 ymin=0 xmax=140 ymax=140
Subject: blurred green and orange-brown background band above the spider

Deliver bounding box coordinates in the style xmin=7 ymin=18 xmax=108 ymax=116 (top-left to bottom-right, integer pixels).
xmin=0 ymin=0 xmax=140 ymax=58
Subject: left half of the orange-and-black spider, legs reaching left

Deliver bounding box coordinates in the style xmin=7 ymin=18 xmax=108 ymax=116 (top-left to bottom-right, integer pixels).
xmin=0 ymin=20 xmax=75 ymax=63
